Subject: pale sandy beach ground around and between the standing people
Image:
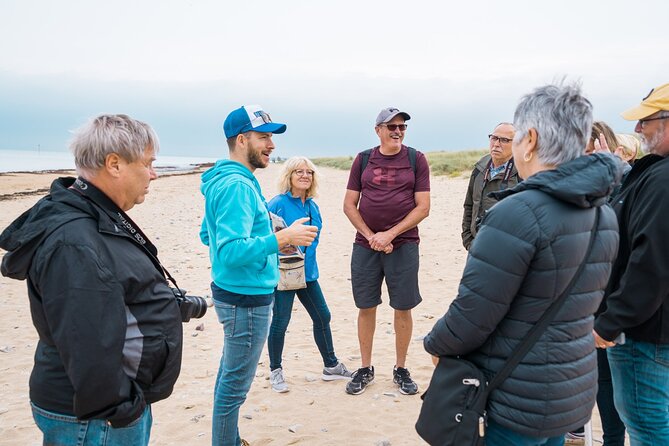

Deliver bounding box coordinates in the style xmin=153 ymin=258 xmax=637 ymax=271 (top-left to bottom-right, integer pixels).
xmin=0 ymin=164 xmax=601 ymax=446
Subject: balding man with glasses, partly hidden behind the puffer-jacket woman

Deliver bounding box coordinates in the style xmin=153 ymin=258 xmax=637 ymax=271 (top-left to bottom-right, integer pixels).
xmin=462 ymin=122 xmax=520 ymax=251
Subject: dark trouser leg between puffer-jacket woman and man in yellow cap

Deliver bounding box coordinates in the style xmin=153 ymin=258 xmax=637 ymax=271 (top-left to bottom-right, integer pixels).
xmin=597 ymin=348 xmax=625 ymax=446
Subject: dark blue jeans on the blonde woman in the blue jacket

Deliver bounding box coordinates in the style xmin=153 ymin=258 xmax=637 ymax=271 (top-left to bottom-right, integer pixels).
xmin=267 ymin=280 xmax=339 ymax=370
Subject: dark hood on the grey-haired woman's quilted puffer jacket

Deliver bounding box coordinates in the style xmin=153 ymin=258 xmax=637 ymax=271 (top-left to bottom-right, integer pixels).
xmin=491 ymin=153 xmax=623 ymax=208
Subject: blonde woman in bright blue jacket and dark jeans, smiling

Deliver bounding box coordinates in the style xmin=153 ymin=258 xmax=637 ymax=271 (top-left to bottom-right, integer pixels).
xmin=267 ymin=157 xmax=351 ymax=393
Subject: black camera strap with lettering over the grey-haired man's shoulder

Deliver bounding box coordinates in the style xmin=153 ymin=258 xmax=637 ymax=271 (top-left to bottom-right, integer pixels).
xmin=70 ymin=177 xmax=181 ymax=290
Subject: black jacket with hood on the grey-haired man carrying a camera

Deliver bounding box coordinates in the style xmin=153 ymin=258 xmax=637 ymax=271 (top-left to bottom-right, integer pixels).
xmin=0 ymin=178 xmax=182 ymax=427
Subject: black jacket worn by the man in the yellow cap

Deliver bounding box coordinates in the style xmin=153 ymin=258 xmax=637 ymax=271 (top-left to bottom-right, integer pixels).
xmin=595 ymin=155 xmax=669 ymax=344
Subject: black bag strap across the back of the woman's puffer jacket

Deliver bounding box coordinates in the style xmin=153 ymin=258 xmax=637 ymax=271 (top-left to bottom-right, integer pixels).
xmin=486 ymin=207 xmax=601 ymax=394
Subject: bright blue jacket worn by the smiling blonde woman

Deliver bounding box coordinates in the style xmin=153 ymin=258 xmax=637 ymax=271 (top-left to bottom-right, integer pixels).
xmin=269 ymin=191 xmax=323 ymax=282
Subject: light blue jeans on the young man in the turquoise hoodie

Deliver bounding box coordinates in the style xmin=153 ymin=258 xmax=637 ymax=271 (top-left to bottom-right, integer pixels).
xmin=212 ymin=300 xmax=272 ymax=446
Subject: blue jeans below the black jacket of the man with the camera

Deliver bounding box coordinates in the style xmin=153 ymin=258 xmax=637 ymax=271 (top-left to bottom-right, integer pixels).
xmin=31 ymin=403 xmax=153 ymax=446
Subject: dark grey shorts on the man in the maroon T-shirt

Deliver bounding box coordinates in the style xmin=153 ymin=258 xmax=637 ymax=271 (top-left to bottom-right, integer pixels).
xmin=351 ymin=243 xmax=423 ymax=310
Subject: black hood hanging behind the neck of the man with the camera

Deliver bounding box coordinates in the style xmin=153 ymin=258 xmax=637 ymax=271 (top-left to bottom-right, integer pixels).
xmin=0 ymin=177 xmax=104 ymax=280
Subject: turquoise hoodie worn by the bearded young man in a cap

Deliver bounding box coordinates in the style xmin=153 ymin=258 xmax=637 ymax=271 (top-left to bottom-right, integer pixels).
xmin=200 ymin=160 xmax=279 ymax=300
